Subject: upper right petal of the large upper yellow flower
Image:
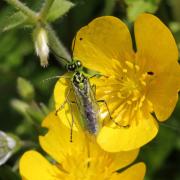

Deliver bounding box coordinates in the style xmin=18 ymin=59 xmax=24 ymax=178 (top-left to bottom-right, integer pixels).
xmin=134 ymin=14 xmax=178 ymax=73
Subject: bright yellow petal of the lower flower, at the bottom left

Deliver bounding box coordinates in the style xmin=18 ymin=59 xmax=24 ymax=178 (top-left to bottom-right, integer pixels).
xmin=19 ymin=151 xmax=60 ymax=180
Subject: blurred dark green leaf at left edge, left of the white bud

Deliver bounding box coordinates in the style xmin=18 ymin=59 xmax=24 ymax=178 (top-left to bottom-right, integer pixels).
xmin=0 ymin=30 xmax=34 ymax=72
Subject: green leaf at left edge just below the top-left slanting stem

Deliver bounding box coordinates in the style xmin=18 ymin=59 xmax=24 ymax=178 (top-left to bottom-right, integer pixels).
xmin=0 ymin=11 xmax=28 ymax=32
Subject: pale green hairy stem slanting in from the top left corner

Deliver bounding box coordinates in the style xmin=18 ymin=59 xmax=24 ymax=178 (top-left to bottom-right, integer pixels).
xmin=5 ymin=0 xmax=38 ymax=22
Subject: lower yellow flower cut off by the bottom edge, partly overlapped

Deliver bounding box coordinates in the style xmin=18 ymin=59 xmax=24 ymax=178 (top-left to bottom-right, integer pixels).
xmin=20 ymin=112 xmax=145 ymax=180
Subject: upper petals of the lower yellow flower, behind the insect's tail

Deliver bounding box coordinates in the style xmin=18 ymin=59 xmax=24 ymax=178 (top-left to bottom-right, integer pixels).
xmin=40 ymin=113 xmax=139 ymax=174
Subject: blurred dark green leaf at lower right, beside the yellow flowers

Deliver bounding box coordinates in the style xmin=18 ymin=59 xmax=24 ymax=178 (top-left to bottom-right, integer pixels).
xmin=140 ymin=122 xmax=178 ymax=175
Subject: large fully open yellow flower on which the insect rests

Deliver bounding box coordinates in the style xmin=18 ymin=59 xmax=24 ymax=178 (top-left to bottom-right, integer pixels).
xmin=54 ymin=14 xmax=180 ymax=152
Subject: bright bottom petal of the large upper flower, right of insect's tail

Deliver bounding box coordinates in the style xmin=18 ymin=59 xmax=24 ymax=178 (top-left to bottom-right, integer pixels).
xmin=97 ymin=116 xmax=158 ymax=152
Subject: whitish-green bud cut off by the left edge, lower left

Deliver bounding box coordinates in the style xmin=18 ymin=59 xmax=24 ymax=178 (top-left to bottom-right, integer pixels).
xmin=0 ymin=131 xmax=16 ymax=166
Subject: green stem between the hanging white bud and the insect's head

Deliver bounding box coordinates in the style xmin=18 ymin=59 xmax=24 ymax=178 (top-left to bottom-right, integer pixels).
xmin=45 ymin=24 xmax=71 ymax=65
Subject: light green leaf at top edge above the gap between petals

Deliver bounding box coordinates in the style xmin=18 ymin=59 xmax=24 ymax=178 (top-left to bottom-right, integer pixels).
xmin=125 ymin=0 xmax=160 ymax=21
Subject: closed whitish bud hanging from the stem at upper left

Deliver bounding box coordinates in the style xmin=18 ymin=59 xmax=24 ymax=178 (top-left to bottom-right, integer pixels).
xmin=34 ymin=27 xmax=49 ymax=67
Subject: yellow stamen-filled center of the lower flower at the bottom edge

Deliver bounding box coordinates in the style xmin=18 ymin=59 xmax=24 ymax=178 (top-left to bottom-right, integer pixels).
xmin=57 ymin=145 xmax=115 ymax=180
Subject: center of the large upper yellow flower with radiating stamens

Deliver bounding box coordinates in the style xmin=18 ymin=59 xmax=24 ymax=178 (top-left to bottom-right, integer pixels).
xmin=99 ymin=61 xmax=154 ymax=126
